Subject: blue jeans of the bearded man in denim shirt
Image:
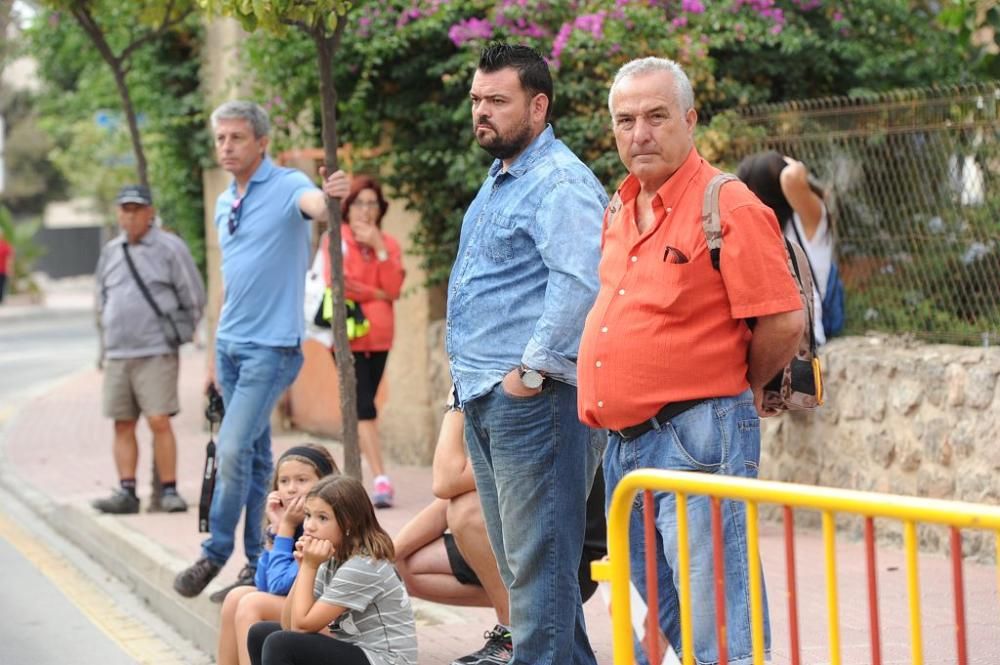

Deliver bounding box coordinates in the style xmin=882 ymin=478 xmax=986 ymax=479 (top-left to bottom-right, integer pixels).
xmin=465 ymin=380 xmax=606 ymax=665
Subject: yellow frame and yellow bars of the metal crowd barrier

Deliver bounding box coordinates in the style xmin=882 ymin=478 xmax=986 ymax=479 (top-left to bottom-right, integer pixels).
xmin=591 ymin=469 xmax=1000 ymax=665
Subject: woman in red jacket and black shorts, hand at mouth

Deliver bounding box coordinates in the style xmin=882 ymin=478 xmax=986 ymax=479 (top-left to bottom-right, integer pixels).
xmin=320 ymin=176 xmax=404 ymax=508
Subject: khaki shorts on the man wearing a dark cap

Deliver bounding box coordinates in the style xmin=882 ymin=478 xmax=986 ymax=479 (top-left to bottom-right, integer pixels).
xmin=104 ymin=353 xmax=181 ymax=420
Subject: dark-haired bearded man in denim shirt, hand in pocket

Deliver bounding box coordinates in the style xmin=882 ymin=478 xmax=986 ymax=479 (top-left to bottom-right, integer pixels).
xmin=447 ymin=44 xmax=607 ymax=665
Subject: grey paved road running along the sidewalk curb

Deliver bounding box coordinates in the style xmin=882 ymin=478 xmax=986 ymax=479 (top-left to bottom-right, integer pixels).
xmin=0 ymin=306 xmax=208 ymax=665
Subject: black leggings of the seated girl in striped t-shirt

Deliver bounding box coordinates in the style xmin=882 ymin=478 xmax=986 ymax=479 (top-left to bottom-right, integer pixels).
xmin=247 ymin=621 xmax=369 ymax=665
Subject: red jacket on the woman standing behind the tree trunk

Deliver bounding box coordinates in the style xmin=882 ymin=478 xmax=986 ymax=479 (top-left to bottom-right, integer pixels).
xmin=321 ymin=224 xmax=405 ymax=351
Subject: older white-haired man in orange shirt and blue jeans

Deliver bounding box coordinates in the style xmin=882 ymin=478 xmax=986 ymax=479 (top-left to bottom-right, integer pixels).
xmin=578 ymin=58 xmax=804 ymax=665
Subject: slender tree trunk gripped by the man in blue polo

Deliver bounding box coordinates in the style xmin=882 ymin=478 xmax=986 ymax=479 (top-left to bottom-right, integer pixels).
xmin=312 ymin=24 xmax=361 ymax=480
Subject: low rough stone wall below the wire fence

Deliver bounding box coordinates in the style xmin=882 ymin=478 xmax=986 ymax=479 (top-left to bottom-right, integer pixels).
xmin=761 ymin=336 xmax=1000 ymax=559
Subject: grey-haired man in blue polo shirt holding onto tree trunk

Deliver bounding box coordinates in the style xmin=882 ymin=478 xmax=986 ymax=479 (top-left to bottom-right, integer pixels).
xmin=174 ymin=101 xmax=349 ymax=601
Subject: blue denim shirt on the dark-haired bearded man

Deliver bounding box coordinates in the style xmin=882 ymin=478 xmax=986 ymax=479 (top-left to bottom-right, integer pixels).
xmin=446 ymin=126 xmax=608 ymax=404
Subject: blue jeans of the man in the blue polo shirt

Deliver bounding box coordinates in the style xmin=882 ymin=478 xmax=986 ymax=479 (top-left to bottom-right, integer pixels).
xmin=201 ymin=340 xmax=302 ymax=566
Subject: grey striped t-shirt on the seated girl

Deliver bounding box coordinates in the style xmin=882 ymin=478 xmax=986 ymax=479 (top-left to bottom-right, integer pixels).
xmin=313 ymin=556 xmax=417 ymax=665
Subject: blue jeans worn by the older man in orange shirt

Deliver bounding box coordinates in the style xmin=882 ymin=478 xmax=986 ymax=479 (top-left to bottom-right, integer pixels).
xmin=604 ymin=390 xmax=771 ymax=665
